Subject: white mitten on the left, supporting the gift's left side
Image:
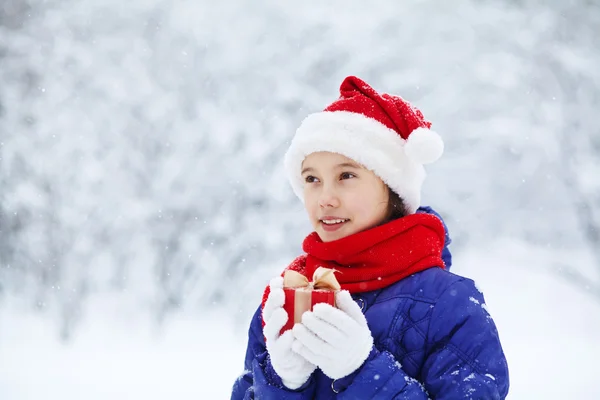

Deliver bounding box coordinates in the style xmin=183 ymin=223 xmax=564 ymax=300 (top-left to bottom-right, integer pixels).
xmin=263 ymin=277 xmax=317 ymax=389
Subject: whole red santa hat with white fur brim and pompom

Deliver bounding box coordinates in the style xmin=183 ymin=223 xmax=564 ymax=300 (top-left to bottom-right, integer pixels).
xmin=285 ymin=76 xmax=444 ymax=213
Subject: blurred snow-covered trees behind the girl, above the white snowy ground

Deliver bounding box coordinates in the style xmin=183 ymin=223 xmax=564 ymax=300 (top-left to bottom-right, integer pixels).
xmin=0 ymin=0 xmax=600 ymax=337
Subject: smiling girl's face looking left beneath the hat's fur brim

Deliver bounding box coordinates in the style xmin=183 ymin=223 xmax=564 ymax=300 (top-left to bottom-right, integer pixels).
xmin=302 ymin=152 xmax=389 ymax=242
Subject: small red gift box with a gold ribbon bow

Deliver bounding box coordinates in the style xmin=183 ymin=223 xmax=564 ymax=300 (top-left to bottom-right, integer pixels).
xmin=281 ymin=267 xmax=341 ymax=333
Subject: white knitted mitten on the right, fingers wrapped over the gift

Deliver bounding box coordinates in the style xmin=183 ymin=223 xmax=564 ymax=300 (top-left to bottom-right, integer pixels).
xmin=292 ymin=290 xmax=373 ymax=379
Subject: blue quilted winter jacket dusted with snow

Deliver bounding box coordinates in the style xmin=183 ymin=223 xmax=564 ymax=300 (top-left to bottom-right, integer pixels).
xmin=231 ymin=208 xmax=509 ymax=400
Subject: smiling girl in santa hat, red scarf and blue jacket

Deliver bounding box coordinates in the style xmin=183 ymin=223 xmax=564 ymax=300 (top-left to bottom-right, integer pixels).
xmin=231 ymin=77 xmax=508 ymax=400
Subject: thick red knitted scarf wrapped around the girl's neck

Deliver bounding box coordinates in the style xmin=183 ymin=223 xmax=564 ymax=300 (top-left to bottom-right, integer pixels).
xmin=263 ymin=214 xmax=444 ymax=312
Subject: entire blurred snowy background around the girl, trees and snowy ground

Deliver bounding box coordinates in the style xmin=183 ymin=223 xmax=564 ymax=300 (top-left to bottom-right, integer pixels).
xmin=0 ymin=0 xmax=600 ymax=400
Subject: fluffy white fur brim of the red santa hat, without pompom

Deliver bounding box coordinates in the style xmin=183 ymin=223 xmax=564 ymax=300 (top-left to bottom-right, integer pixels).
xmin=285 ymin=111 xmax=425 ymax=213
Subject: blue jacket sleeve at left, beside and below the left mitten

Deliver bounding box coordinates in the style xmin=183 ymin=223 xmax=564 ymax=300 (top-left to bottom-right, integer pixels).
xmin=231 ymin=307 xmax=315 ymax=400
